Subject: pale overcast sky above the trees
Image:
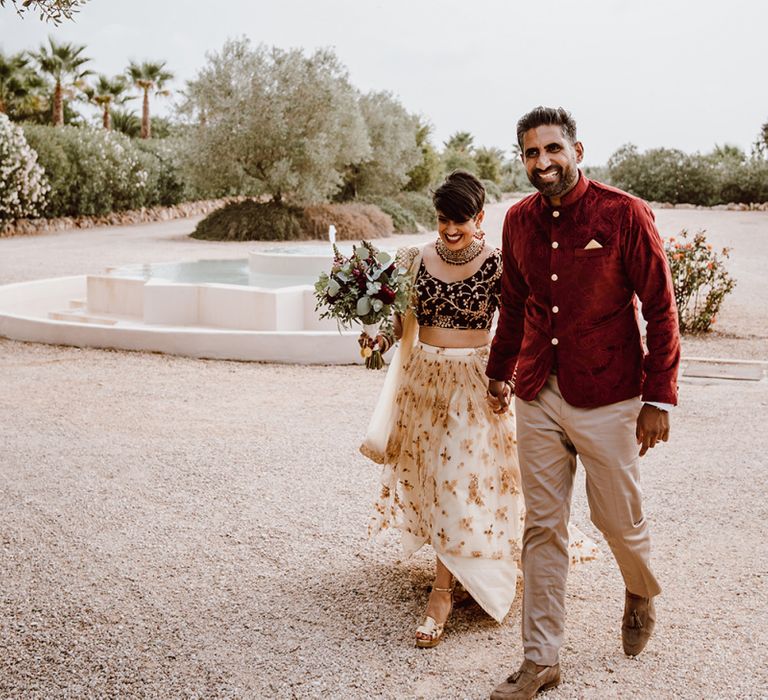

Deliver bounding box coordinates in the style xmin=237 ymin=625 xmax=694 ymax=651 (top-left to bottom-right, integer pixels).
xmin=0 ymin=0 xmax=768 ymax=165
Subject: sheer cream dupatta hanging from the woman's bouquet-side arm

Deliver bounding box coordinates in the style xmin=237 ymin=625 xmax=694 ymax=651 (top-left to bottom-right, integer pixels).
xmin=360 ymin=248 xmax=421 ymax=464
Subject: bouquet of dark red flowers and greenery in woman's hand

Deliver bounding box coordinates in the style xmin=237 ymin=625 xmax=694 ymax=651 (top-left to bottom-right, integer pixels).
xmin=315 ymin=241 xmax=410 ymax=369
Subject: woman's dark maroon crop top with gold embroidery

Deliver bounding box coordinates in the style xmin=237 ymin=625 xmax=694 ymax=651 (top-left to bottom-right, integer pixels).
xmin=414 ymin=250 xmax=501 ymax=330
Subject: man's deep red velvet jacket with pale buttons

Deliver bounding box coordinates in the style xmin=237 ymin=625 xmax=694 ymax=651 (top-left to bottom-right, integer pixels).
xmin=486 ymin=174 xmax=680 ymax=408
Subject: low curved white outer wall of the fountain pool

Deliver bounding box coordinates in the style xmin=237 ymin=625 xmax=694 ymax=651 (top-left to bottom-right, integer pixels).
xmin=0 ymin=275 xmax=368 ymax=364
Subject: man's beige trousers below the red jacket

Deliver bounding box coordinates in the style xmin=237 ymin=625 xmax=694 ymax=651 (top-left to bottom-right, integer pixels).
xmin=515 ymin=375 xmax=661 ymax=666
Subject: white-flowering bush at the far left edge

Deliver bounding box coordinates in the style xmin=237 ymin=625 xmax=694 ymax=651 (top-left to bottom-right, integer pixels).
xmin=0 ymin=113 xmax=50 ymax=226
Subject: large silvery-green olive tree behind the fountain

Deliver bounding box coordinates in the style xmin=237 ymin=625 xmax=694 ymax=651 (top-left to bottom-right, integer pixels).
xmin=182 ymin=39 xmax=371 ymax=204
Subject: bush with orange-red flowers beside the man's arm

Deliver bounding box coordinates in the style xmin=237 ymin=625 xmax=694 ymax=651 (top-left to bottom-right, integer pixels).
xmin=664 ymin=229 xmax=736 ymax=333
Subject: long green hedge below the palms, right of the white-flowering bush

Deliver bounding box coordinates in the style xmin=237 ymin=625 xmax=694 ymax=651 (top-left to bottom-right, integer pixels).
xmin=24 ymin=124 xmax=184 ymax=217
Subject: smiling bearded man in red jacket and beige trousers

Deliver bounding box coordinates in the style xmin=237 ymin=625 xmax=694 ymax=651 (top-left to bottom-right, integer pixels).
xmin=486 ymin=107 xmax=680 ymax=700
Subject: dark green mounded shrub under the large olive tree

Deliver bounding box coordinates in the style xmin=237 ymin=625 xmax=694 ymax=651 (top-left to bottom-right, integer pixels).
xmin=192 ymin=199 xmax=308 ymax=241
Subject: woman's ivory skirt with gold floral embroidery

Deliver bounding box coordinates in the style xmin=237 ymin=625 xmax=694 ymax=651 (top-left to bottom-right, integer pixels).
xmin=370 ymin=343 xmax=523 ymax=621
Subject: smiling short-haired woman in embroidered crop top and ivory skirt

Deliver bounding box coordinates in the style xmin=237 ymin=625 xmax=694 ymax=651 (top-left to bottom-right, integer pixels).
xmin=361 ymin=171 xmax=595 ymax=647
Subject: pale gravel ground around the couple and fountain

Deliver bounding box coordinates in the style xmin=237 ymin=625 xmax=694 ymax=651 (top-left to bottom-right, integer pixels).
xmin=0 ymin=202 xmax=768 ymax=699
